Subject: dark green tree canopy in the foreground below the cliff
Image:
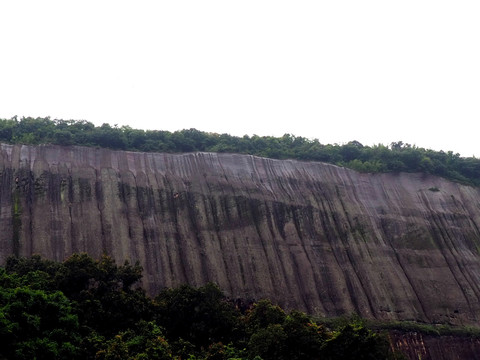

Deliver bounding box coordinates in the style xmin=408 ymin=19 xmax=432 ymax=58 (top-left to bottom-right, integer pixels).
xmin=0 ymin=254 xmax=400 ymax=360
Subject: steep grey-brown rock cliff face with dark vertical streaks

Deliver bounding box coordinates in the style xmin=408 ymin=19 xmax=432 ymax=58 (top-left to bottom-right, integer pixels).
xmin=0 ymin=145 xmax=480 ymax=325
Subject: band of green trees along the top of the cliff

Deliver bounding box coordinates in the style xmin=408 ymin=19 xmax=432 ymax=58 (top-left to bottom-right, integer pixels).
xmin=0 ymin=117 xmax=480 ymax=186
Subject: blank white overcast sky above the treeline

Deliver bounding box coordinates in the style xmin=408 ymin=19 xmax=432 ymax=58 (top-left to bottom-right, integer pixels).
xmin=0 ymin=0 xmax=480 ymax=157
